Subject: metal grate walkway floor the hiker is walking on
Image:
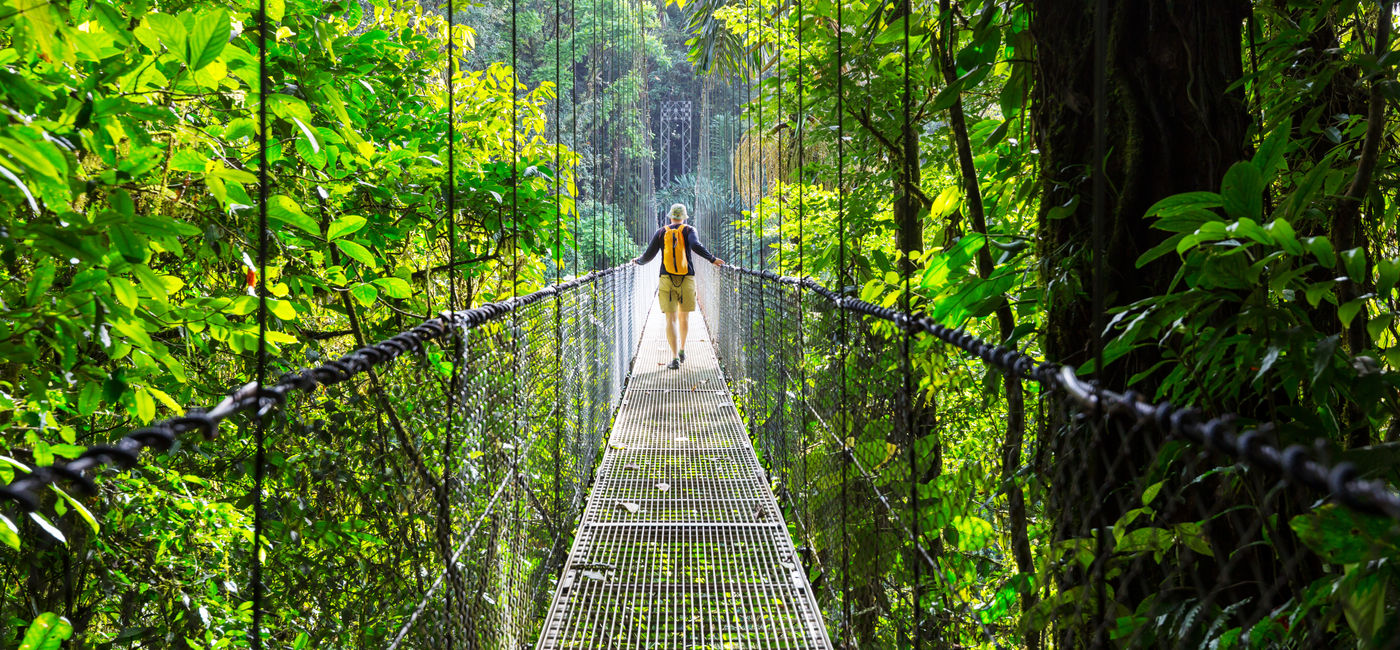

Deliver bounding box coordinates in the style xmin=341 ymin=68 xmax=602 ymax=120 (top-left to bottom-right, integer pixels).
xmin=539 ymin=310 xmax=832 ymax=650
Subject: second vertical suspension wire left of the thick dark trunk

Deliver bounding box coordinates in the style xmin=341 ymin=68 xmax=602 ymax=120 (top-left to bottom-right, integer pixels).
xmin=834 ymin=0 xmax=854 ymax=646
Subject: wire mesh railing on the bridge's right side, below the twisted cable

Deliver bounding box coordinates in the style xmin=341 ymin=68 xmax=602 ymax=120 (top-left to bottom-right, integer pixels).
xmin=700 ymin=268 xmax=1400 ymax=647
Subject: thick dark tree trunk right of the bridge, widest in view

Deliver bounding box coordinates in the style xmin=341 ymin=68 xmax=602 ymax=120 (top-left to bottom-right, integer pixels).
xmin=1032 ymin=0 xmax=1250 ymax=647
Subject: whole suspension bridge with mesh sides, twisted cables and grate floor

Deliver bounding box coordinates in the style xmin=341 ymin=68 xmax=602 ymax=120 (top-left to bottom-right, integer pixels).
xmin=3 ymin=256 xmax=1400 ymax=649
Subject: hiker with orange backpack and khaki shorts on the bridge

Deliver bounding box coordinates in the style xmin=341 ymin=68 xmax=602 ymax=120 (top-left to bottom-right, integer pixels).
xmin=631 ymin=203 xmax=724 ymax=370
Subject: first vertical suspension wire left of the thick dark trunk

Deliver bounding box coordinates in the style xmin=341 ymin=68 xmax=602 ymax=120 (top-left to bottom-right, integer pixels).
xmin=895 ymin=0 xmax=924 ymax=638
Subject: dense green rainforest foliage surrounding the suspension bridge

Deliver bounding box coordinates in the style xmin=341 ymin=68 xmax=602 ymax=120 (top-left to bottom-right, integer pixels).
xmin=0 ymin=0 xmax=1400 ymax=647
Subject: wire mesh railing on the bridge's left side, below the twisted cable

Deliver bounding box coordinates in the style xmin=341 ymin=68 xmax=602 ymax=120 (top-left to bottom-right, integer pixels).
xmin=0 ymin=265 xmax=657 ymax=649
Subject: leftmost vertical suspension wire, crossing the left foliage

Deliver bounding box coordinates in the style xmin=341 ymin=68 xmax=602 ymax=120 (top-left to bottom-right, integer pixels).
xmin=252 ymin=0 xmax=272 ymax=650
